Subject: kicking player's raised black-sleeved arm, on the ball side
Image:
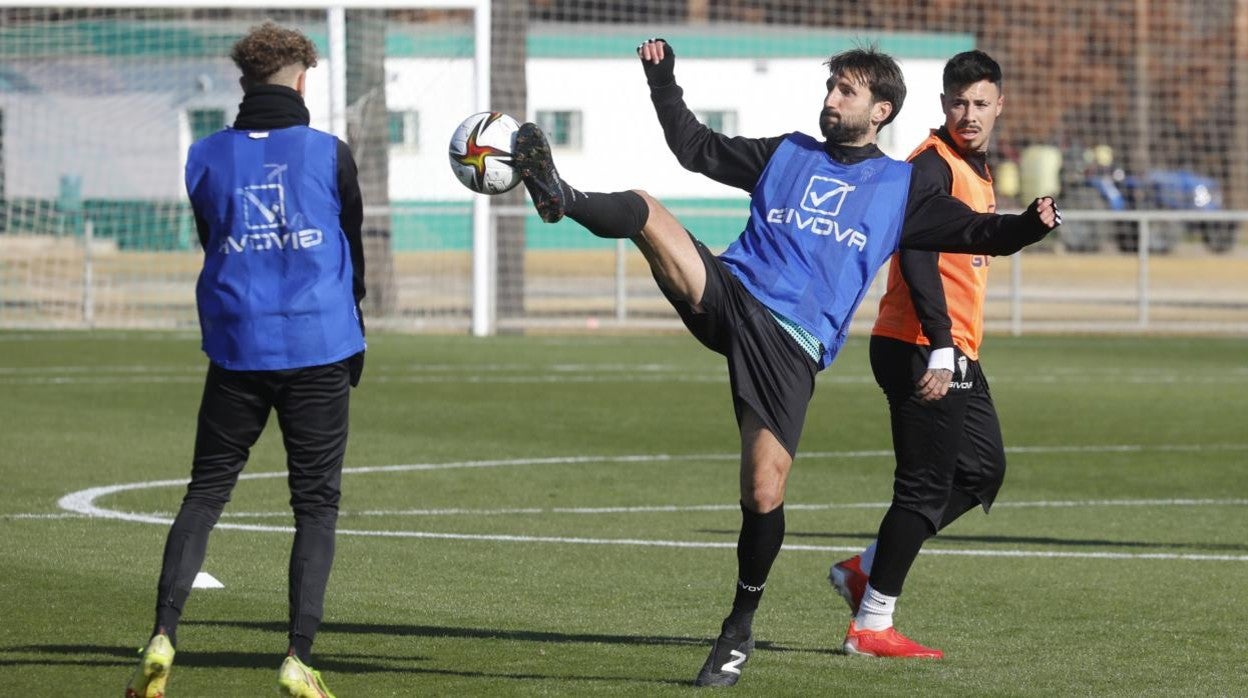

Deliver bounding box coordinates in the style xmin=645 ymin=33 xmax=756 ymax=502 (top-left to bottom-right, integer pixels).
xmin=636 ymin=39 xmax=782 ymax=191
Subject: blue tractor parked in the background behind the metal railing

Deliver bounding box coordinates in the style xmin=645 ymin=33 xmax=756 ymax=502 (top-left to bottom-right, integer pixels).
xmin=1061 ymin=146 xmax=1236 ymax=253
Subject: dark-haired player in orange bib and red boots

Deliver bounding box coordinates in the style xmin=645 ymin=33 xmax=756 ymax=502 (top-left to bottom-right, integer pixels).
xmin=829 ymin=51 xmax=1006 ymax=658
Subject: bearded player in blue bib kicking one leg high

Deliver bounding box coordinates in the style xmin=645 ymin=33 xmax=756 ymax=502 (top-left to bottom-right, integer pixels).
xmin=501 ymin=39 xmax=1061 ymax=686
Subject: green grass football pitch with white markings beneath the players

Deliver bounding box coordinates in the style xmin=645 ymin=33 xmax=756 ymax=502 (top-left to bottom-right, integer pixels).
xmin=0 ymin=331 xmax=1248 ymax=698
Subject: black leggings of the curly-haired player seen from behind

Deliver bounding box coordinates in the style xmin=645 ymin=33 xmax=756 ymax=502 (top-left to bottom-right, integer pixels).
xmin=156 ymin=361 xmax=351 ymax=642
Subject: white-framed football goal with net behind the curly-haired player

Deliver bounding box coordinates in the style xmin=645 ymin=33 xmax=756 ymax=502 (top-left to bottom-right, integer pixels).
xmin=0 ymin=0 xmax=488 ymax=327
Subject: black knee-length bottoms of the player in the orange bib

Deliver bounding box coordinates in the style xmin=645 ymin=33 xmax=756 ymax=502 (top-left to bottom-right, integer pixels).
xmin=871 ymin=336 xmax=1006 ymax=528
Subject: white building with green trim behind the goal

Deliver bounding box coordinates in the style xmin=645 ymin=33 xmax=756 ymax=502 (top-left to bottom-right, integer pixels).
xmin=0 ymin=25 xmax=972 ymax=248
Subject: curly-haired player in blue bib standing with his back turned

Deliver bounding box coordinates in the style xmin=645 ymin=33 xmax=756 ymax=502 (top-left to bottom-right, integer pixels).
xmin=126 ymin=22 xmax=364 ymax=698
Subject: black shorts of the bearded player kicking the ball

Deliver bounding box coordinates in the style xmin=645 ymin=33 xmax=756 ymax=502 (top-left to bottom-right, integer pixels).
xmin=659 ymin=236 xmax=819 ymax=456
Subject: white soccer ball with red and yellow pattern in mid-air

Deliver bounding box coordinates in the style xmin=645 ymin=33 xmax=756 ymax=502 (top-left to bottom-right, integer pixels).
xmin=449 ymin=111 xmax=520 ymax=194
